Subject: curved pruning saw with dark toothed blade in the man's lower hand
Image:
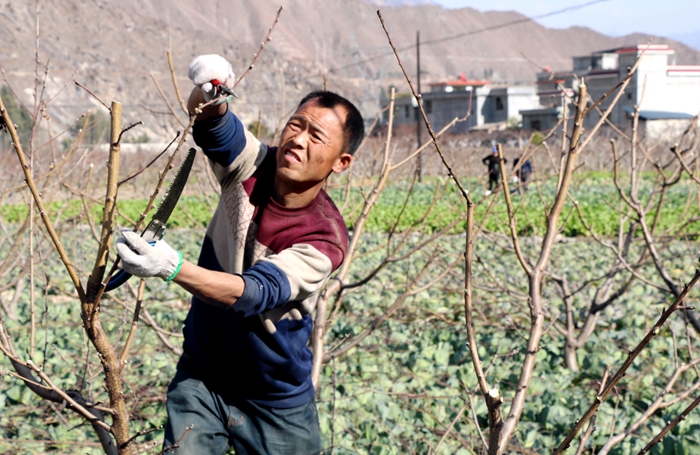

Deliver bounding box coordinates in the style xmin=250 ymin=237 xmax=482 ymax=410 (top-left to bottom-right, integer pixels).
xmin=105 ymin=148 xmax=197 ymax=292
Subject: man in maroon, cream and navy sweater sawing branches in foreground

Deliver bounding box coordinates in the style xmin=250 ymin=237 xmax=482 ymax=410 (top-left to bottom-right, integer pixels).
xmin=117 ymin=55 xmax=364 ymax=455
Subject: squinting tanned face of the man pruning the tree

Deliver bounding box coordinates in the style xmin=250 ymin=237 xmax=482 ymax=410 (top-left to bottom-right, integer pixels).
xmin=276 ymin=99 xmax=352 ymax=191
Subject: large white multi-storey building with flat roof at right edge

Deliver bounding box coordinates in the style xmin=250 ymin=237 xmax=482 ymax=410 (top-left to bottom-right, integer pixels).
xmin=521 ymin=45 xmax=700 ymax=133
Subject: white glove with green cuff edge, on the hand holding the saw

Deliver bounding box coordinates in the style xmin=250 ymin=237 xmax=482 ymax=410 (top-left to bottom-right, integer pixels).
xmin=117 ymin=229 xmax=182 ymax=281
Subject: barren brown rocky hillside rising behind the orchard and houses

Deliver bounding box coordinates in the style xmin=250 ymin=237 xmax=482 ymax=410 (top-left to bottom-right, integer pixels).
xmin=0 ymin=0 xmax=700 ymax=141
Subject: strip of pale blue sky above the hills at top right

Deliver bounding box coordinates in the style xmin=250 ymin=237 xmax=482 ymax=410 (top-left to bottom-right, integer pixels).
xmin=433 ymin=0 xmax=700 ymax=37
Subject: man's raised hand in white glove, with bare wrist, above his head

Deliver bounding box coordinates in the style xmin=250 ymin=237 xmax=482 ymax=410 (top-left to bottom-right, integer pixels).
xmin=187 ymin=54 xmax=235 ymax=121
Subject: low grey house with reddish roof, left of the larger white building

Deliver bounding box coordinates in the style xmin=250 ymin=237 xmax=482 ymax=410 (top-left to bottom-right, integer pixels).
xmin=381 ymin=73 xmax=538 ymax=133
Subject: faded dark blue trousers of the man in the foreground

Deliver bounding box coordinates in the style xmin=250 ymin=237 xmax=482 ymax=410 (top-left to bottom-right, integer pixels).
xmin=163 ymin=370 xmax=322 ymax=455
